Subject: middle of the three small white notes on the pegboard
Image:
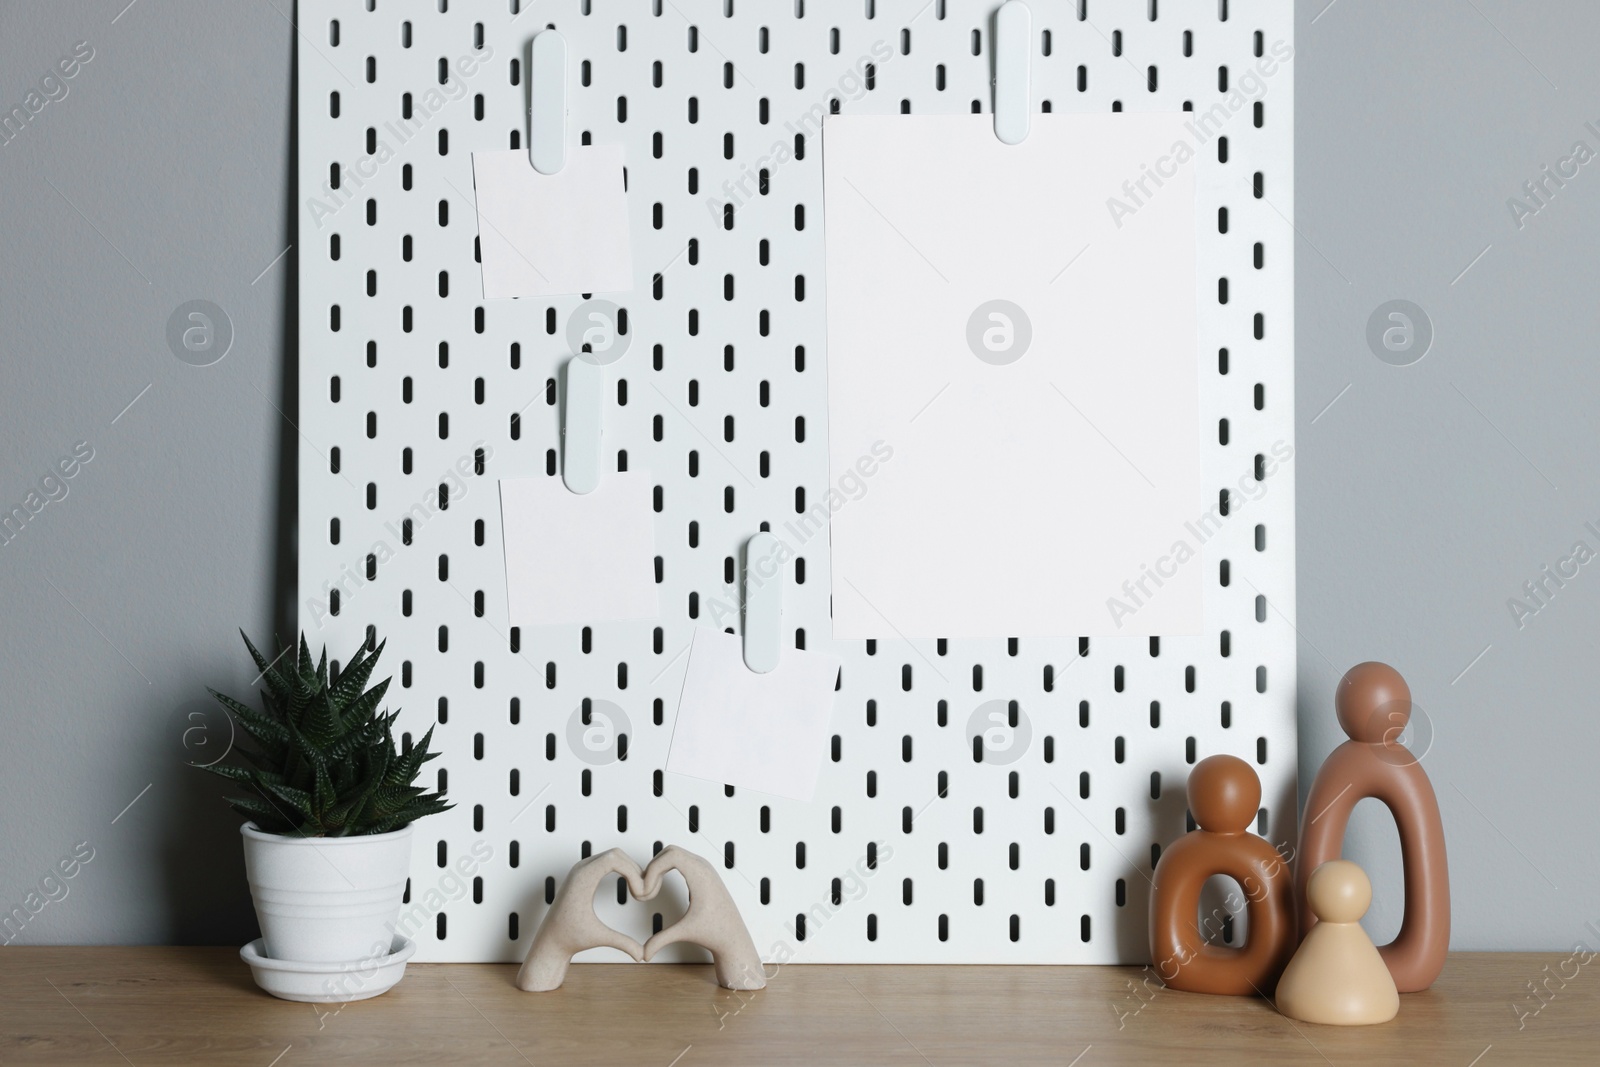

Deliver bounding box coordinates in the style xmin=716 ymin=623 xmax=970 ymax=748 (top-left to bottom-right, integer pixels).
xmin=499 ymin=470 xmax=661 ymax=625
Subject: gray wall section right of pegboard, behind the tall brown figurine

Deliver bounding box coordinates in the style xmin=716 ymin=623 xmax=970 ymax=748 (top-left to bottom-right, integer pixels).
xmin=1294 ymin=0 xmax=1600 ymax=949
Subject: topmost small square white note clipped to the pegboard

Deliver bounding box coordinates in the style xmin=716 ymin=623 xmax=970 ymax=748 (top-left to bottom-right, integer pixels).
xmin=472 ymin=144 xmax=634 ymax=299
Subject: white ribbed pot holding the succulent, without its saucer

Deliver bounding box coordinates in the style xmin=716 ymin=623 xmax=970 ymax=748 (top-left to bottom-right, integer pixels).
xmin=240 ymin=822 xmax=411 ymax=963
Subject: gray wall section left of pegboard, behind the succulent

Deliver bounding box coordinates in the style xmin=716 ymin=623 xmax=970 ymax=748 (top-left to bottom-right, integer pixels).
xmin=0 ymin=0 xmax=294 ymax=944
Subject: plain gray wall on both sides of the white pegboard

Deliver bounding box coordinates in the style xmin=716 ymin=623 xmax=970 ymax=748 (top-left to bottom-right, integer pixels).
xmin=0 ymin=0 xmax=1600 ymax=950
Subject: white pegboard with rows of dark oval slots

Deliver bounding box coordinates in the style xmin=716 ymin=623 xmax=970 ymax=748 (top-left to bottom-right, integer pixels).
xmin=296 ymin=0 xmax=1296 ymax=963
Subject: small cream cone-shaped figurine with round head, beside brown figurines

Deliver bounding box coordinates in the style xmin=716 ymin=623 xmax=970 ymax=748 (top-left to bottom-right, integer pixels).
xmin=1278 ymin=859 xmax=1400 ymax=1025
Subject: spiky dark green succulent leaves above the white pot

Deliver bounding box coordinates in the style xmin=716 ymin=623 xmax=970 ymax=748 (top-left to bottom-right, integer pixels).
xmin=203 ymin=630 xmax=450 ymax=837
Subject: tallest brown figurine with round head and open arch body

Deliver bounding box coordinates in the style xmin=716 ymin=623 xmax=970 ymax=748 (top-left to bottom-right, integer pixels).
xmin=1294 ymin=662 xmax=1450 ymax=993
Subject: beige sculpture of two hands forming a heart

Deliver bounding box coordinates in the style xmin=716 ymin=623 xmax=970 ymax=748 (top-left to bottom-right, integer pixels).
xmin=517 ymin=845 xmax=766 ymax=992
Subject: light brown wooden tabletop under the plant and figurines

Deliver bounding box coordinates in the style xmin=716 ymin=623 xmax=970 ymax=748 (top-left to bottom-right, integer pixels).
xmin=0 ymin=947 xmax=1600 ymax=1067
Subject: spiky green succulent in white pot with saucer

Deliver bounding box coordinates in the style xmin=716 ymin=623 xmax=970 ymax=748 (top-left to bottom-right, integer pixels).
xmin=205 ymin=632 xmax=450 ymax=1000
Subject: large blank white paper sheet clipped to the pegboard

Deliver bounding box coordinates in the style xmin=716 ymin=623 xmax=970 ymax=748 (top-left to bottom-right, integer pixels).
xmin=819 ymin=114 xmax=1216 ymax=638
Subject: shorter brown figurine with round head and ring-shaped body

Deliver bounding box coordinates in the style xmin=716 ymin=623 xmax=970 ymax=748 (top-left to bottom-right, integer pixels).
xmin=1150 ymin=755 xmax=1298 ymax=997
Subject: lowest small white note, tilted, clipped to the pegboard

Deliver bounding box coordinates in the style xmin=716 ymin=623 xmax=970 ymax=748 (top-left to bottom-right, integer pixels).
xmin=667 ymin=629 xmax=838 ymax=800
